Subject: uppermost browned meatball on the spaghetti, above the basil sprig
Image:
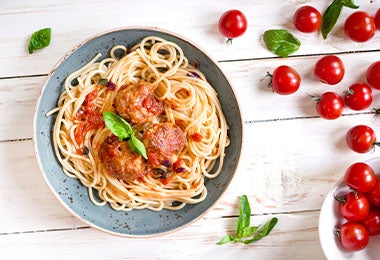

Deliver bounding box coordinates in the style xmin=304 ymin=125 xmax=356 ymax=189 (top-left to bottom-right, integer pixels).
xmin=114 ymin=82 xmax=164 ymax=124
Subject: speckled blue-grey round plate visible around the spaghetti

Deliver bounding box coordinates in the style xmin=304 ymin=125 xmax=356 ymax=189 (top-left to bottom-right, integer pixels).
xmin=33 ymin=27 xmax=242 ymax=236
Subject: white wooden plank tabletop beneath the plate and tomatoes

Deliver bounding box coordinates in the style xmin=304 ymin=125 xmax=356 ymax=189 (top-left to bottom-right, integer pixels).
xmin=0 ymin=0 xmax=380 ymax=259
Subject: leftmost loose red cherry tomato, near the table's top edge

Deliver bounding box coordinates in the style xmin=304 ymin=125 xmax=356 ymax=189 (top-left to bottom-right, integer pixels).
xmin=218 ymin=10 xmax=248 ymax=43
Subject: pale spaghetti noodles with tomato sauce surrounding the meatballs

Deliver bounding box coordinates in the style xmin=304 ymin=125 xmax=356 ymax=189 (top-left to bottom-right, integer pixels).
xmin=50 ymin=37 xmax=229 ymax=211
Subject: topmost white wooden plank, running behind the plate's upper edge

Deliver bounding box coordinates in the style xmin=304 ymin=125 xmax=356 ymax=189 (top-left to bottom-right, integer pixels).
xmin=0 ymin=0 xmax=380 ymax=78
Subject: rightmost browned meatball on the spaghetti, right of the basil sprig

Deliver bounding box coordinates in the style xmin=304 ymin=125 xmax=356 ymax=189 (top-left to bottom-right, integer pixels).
xmin=143 ymin=123 xmax=186 ymax=166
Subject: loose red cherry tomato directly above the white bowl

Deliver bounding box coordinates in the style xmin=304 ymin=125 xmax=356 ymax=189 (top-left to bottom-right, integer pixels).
xmin=346 ymin=125 xmax=376 ymax=153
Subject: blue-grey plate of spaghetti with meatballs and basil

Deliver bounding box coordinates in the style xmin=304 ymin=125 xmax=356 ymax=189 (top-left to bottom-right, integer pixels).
xmin=33 ymin=27 xmax=242 ymax=236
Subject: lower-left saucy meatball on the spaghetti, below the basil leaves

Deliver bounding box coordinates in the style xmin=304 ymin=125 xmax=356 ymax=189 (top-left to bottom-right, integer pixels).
xmin=99 ymin=136 xmax=146 ymax=181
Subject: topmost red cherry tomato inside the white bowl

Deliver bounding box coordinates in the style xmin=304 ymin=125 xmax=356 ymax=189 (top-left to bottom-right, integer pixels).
xmin=344 ymin=162 xmax=376 ymax=193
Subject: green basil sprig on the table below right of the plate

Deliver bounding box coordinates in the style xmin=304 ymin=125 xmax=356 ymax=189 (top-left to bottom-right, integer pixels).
xmin=216 ymin=195 xmax=278 ymax=245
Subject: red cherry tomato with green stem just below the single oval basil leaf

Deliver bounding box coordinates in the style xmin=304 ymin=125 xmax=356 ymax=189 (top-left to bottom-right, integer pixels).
xmin=270 ymin=65 xmax=301 ymax=95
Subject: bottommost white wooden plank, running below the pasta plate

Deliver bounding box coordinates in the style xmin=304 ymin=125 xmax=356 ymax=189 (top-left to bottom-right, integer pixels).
xmin=0 ymin=212 xmax=323 ymax=259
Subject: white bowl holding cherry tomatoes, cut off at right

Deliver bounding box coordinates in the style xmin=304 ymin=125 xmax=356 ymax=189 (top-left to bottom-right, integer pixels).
xmin=318 ymin=157 xmax=380 ymax=260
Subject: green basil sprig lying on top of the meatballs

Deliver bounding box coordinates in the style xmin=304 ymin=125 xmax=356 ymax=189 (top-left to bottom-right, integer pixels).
xmin=103 ymin=111 xmax=148 ymax=159
